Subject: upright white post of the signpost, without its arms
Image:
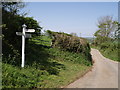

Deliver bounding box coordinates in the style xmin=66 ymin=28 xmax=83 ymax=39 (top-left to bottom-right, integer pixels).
xmin=21 ymin=24 xmax=27 ymax=67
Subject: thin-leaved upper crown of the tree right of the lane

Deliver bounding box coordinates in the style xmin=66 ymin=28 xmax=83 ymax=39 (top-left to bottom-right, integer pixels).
xmin=95 ymin=16 xmax=117 ymax=37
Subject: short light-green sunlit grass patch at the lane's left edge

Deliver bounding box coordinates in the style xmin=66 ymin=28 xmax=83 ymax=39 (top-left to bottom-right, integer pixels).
xmin=42 ymin=62 xmax=91 ymax=88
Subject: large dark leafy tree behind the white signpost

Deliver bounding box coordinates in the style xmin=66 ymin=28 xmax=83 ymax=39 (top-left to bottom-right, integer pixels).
xmin=2 ymin=2 xmax=42 ymax=64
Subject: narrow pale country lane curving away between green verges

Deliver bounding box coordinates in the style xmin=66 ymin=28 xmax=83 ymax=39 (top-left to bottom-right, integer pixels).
xmin=66 ymin=49 xmax=118 ymax=88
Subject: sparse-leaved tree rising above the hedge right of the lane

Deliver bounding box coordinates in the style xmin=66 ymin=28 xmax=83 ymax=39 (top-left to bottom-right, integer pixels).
xmin=94 ymin=16 xmax=118 ymax=44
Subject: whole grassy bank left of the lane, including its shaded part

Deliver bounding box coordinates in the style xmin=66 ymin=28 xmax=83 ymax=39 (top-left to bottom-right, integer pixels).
xmin=2 ymin=36 xmax=92 ymax=88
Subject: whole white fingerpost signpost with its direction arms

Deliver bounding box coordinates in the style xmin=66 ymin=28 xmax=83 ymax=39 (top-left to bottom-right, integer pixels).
xmin=16 ymin=24 xmax=35 ymax=67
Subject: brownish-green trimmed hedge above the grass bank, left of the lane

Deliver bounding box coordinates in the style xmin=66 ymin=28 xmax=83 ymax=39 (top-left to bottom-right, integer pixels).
xmin=47 ymin=31 xmax=91 ymax=60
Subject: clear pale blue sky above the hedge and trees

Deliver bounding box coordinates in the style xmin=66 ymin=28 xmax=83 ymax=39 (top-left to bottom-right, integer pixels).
xmin=23 ymin=2 xmax=118 ymax=37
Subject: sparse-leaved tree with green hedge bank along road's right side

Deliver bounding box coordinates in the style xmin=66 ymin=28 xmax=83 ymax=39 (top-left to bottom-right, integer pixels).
xmin=92 ymin=16 xmax=120 ymax=61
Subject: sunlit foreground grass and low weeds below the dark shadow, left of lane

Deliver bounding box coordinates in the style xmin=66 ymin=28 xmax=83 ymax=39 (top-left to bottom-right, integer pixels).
xmin=2 ymin=62 xmax=91 ymax=88
